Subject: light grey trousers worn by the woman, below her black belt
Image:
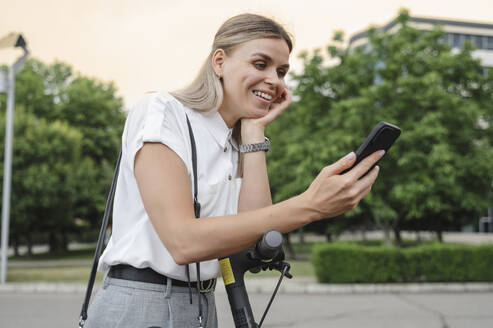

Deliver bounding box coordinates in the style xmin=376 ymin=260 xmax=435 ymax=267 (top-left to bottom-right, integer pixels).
xmin=84 ymin=277 xmax=217 ymax=328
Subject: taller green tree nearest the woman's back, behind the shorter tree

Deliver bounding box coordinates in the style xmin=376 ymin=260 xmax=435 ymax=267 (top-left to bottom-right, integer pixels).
xmin=56 ymin=76 xmax=125 ymax=224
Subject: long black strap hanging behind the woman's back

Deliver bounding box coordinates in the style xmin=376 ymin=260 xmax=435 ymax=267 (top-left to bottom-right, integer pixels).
xmin=79 ymin=150 xmax=122 ymax=328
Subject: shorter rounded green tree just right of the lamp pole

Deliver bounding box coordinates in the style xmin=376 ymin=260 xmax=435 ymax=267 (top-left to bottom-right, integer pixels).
xmin=0 ymin=108 xmax=87 ymax=251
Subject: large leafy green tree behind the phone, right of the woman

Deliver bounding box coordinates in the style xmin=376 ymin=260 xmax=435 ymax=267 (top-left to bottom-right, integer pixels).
xmin=269 ymin=11 xmax=493 ymax=246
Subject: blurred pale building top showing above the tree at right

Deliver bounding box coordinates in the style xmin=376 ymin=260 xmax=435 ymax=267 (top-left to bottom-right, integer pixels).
xmin=349 ymin=17 xmax=493 ymax=68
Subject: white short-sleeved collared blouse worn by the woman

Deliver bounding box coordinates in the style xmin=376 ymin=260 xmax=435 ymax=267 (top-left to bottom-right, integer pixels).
xmin=98 ymin=92 xmax=241 ymax=281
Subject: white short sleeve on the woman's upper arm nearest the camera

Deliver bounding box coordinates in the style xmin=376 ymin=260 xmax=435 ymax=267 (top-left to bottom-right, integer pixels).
xmin=124 ymin=93 xmax=190 ymax=174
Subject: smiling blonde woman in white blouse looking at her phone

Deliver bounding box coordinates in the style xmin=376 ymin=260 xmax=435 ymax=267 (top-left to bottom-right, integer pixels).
xmin=86 ymin=14 xmax=383 ymax=327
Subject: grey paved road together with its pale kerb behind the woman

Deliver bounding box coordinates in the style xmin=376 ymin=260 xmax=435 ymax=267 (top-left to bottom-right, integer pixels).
xmin=0 ymin=278 xmax=493 ymax=328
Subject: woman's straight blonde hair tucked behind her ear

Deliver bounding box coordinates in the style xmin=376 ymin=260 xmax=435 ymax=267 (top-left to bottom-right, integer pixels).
xmin=170 ymin=14 xmax=293 ymax=112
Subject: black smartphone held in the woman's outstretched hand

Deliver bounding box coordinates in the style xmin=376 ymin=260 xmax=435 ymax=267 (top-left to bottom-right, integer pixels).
xmin=341 ymin=122 xmax=401 ymax=178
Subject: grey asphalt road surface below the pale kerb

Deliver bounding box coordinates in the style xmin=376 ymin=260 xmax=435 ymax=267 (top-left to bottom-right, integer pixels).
xmin=0 ymin=292 xmax=493 ymax=328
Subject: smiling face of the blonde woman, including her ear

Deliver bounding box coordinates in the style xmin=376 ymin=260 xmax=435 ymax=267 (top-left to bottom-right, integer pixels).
xmin=213 ymin=39 xmax=289 ymax=126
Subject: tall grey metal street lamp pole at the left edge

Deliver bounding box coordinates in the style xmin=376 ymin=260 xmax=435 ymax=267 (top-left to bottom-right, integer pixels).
xmin=0 ymin=47 xmax=29 ymax=285
